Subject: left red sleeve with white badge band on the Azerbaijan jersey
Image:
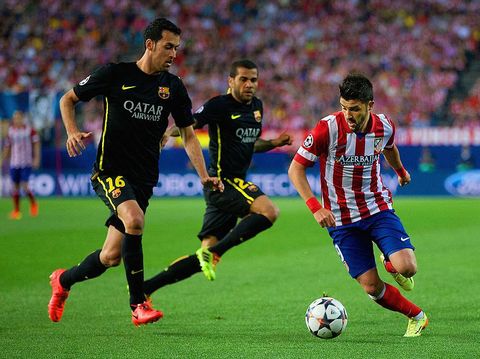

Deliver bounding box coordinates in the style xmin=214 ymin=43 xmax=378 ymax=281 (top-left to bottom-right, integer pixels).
xmin=293 ymin=121 xmax=329 ymax=167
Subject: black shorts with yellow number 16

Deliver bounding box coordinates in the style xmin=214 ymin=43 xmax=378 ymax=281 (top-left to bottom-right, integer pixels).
xmin=91 ymin=172 xmax=153 ymax=233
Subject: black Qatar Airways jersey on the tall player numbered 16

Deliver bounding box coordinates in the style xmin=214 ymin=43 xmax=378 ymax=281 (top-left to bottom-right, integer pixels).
xmin=73 ymin=62 xmax=194 ymax=186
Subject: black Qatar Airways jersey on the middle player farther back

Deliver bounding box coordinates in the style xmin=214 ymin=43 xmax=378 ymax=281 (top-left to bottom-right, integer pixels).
xmin=194 ymin=94 xmax=263 ymax=178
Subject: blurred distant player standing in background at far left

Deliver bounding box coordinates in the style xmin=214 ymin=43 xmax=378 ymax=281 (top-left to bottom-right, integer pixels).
xmin=3 ymin=111 xmax=40 ymax=219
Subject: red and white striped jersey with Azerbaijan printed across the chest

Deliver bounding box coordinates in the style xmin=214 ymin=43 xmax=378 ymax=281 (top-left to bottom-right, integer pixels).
xmin=294 ymin=112 xmax=395 ymax=226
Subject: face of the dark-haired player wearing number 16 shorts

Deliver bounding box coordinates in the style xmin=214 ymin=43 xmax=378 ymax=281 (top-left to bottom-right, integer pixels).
xmin=146 ymin=30 xmax=180 ymax=72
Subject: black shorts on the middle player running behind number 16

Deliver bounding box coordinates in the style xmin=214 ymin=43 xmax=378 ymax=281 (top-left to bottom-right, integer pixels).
xmin=198 ymin=178 xmax=264 ymax=240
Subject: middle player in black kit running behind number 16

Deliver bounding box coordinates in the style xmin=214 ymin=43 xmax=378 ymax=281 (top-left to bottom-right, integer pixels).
xmin=144 ymin=60 xmax=292 ymax=296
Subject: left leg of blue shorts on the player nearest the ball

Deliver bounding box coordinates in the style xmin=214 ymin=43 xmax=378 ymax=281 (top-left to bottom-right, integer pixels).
xmin=329 ymin=224 xmax=376 ymax=278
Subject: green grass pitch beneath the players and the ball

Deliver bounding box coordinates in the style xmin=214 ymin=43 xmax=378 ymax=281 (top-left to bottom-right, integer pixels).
xmin=0 ymin=198 xmax=480 ymax=358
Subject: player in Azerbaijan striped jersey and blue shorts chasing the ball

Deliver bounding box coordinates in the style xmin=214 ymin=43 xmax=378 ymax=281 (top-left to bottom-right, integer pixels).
xmin=288 ymin=74 xmax=428 ymax=337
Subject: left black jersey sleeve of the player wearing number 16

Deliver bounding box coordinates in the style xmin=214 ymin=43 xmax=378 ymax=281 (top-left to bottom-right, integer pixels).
xmin=73 ymin=64 xmax=113 ymax=101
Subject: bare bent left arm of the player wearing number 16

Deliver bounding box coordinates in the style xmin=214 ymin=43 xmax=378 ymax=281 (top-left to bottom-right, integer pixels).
xmin=60 ymin=89 xmax=92 ymax=157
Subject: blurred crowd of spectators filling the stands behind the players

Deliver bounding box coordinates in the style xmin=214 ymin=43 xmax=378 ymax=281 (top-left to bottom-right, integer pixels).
xmin=0 ymin=0 xmax=480 ymax=129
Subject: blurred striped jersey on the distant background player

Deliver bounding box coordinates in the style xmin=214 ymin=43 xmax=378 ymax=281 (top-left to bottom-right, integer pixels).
xmin=6 ymin=125 xmax=40 ymax=168
